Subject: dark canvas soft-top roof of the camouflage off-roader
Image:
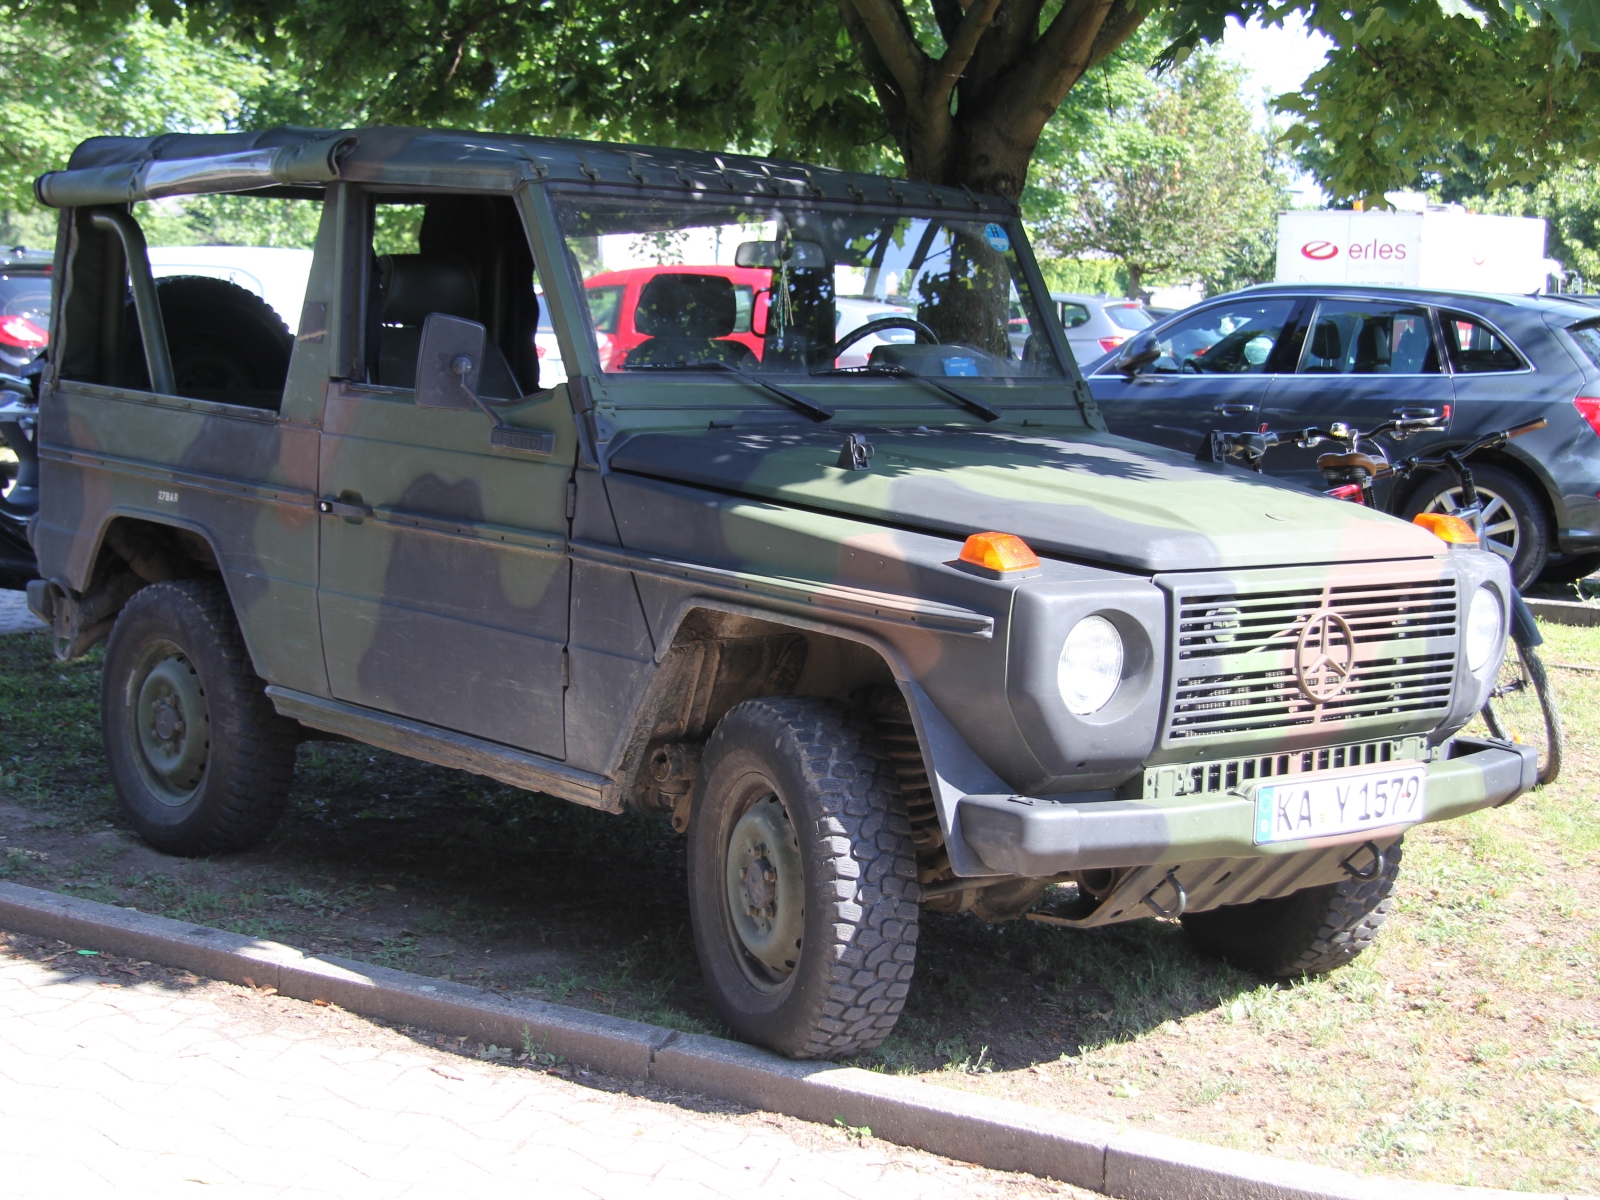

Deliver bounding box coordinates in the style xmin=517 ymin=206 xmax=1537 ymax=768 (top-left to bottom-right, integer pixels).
xmin=34 ymin=125 xmax=1016 ymax=216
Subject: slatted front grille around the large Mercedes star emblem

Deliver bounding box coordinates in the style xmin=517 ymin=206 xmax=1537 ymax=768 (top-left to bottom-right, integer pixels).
xmin=1165 ymin=563 xmax=1459 ymax=746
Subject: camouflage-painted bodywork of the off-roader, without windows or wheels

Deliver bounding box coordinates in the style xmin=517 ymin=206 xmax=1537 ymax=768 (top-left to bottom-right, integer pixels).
xmin=21 ymin=130 xmax=1523 ymax=918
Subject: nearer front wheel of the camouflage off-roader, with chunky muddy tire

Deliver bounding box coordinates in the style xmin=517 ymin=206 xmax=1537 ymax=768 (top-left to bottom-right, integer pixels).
xmin=688 ymin=698 xmax=917 ymax=1058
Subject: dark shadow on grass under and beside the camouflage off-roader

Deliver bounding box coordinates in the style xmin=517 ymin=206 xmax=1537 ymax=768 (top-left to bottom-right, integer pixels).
xmin=0 ymin=635 xmax=1259 ymax=1072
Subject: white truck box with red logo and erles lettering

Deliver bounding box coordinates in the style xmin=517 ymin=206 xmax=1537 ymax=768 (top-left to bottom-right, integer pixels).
xmin=1277 ymin=208 xmax=1560 ymax=293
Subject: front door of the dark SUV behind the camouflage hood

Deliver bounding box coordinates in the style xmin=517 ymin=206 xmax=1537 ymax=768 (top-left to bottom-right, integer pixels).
xmin=1090 ymin=296 xmax=1301 ymax=454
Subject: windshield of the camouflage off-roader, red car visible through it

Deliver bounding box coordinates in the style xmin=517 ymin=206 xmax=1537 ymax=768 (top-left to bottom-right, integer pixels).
xmin=557 ymin=194 xmax=1062 ymax=379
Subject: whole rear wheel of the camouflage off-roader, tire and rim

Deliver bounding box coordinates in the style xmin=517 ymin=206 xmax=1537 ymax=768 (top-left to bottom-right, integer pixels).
xmin=101 ymin=579 xmax=294 ymax=854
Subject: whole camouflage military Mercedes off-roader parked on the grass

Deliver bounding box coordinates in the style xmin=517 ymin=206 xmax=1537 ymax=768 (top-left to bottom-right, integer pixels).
xmin=18 ymin=128 xmax=1533 ymax=1058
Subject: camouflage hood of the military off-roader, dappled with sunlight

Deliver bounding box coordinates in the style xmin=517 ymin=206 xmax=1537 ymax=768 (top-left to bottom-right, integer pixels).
xmin=608 ymin=427 xmax=1445 ymax=573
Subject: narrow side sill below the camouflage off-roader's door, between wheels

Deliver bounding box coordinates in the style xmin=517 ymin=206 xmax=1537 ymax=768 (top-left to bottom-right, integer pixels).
xmin=267 ymin=686 xmax=622 ymax=813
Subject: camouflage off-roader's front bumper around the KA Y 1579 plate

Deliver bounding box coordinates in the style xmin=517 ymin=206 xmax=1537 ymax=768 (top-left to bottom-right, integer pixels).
xmin=957 ymin=738 xmax=1538 ymax=878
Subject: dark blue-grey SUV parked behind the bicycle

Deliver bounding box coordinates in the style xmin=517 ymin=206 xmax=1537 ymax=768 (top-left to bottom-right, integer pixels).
xmin=1090 ymin=285 xmax=1600 ymax=586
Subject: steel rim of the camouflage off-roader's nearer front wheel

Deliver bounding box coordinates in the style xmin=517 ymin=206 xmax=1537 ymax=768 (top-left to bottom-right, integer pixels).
xmin=723 ymin=776 xmax=805 ymax=994
